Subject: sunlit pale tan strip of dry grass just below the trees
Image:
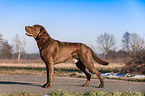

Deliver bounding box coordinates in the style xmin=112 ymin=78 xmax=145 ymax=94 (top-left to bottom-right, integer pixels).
xmin=0 ymin=63 xmax=125 ymax=70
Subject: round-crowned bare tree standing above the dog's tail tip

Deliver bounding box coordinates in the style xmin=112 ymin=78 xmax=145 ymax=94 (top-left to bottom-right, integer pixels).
xmin=96 ymin=33 xmax=116 ymax=59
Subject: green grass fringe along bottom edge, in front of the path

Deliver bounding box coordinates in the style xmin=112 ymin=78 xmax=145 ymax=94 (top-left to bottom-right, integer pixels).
xmin=0 ymin=90 xmax=145 ymax=96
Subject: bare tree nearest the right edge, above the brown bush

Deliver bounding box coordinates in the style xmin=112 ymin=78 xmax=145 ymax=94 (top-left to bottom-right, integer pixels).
xmin=130 ymin=33 xmax=144 ymax=56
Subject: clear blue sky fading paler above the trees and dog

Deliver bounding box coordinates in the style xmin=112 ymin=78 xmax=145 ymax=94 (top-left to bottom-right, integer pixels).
xmin=0 ymin=0 xmax=145 ymax=53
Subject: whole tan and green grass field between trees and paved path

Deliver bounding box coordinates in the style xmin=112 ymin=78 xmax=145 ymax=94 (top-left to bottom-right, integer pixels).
xmin=0 ymin=60 xmax=145 ymax=82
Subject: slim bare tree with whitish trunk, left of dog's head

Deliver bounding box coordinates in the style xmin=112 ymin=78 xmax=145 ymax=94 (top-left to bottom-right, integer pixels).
xmin=13 ymin=34 xmax=26 ymax=61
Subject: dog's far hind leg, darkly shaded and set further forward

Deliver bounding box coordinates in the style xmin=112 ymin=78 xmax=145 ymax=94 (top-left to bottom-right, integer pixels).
xmin=75 ymin=60 xmax=91 ymax=86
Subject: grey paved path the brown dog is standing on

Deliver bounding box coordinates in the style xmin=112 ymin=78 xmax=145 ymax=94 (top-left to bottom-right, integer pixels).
xmin=0 ymin=75 xmax=145 ymax=94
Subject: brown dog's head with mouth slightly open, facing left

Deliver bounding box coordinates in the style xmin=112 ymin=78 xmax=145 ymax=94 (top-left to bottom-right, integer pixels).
xmin=25 ymin=25 xmax=45 ymax=38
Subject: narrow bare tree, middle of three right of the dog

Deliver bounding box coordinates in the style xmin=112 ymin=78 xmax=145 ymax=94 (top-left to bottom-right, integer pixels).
xmin=122 ymin=32 xmax=131 ymax=52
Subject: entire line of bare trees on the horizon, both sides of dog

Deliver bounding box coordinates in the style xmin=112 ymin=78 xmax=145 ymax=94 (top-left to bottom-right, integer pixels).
xmin=0 ymin=32 xmax=145 ymax=61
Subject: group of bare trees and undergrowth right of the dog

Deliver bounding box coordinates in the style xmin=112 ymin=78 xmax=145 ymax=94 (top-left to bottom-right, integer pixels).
xmin=96 ymin=32 xmax=145 ymax=59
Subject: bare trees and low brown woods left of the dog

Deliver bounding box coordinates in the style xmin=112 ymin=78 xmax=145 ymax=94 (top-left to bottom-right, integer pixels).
xmin=0 ymin=34 xmax=40 ymax=61
